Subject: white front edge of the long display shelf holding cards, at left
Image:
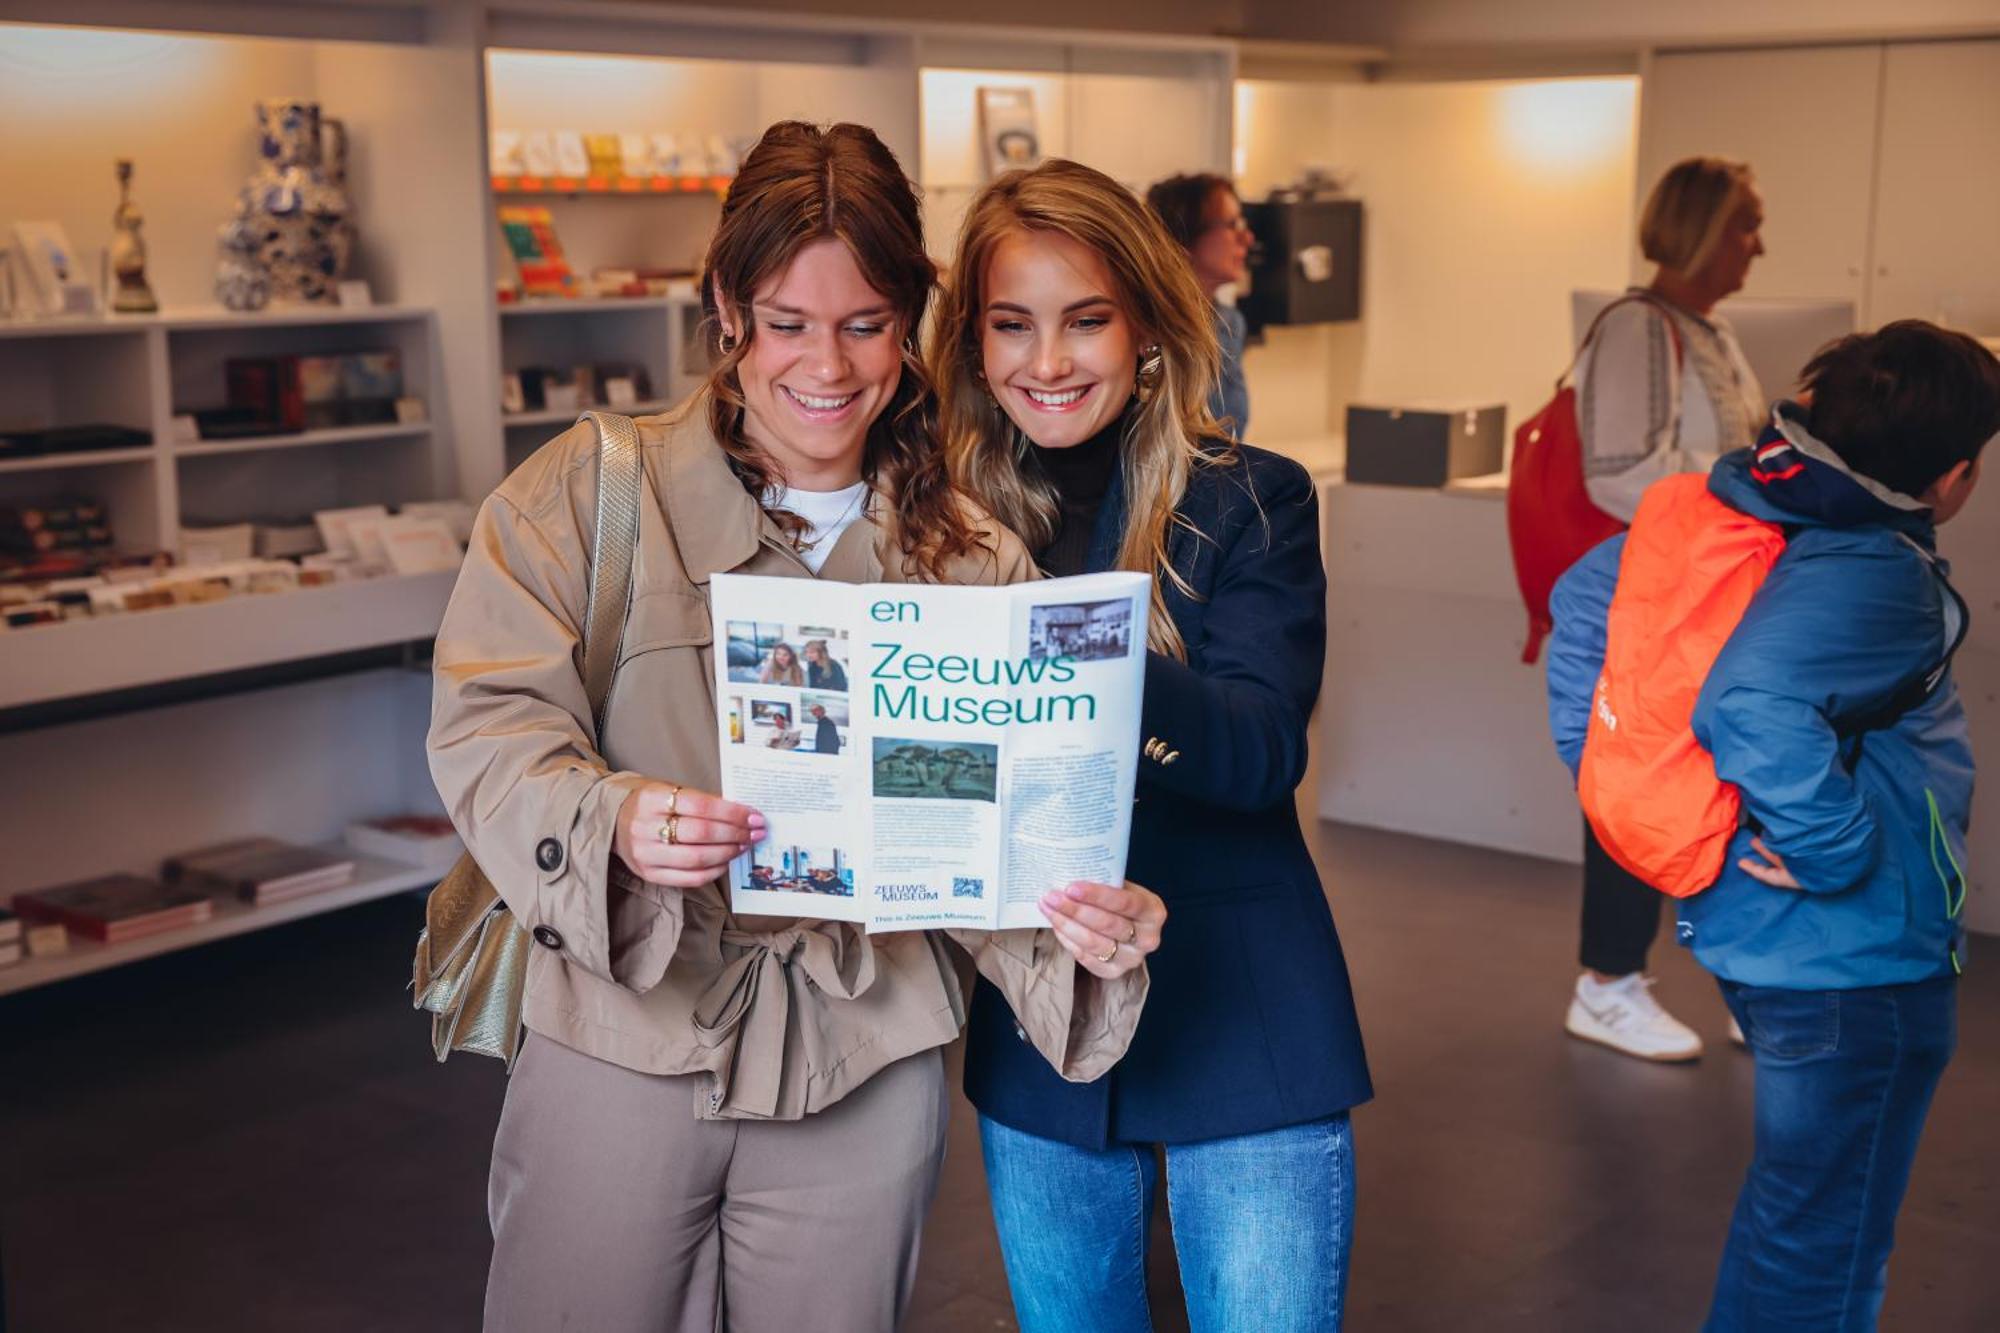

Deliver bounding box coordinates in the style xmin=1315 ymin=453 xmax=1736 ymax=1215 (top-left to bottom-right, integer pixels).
xmin=0 ymin=570 xmax=458 ymax=709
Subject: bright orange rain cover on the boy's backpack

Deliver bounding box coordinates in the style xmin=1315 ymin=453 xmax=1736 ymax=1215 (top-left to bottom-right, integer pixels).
xmin=1576 ymin=472 xmax=1784 ymax=899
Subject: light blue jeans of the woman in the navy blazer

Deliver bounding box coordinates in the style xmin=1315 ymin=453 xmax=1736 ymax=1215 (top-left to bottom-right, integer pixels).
xmin=980 ymin=1113 xmax=1354 ymax=1333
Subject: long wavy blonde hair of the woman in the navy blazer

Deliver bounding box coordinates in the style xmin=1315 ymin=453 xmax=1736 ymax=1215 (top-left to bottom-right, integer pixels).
xmin=928 ymin=158 xmax=1236 ymax=658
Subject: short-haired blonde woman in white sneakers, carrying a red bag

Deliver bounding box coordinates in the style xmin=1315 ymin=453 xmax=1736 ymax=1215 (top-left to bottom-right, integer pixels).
xmin=1564 ymin=158 xmax=1766 ymax=1061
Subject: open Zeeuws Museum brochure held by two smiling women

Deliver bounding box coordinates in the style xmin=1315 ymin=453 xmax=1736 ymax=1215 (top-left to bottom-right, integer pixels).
xmin=710 ymin=572 xmax=1150 ymax=931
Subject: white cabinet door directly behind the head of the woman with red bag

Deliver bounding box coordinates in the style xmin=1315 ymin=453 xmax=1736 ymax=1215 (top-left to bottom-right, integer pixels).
xmin=1634 ymin=46 xmax=1882 ymax=308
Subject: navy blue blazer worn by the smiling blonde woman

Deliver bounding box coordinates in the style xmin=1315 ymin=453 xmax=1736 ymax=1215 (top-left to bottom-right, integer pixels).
xmin=966 ymin=446 xmax=1374 ymax=1149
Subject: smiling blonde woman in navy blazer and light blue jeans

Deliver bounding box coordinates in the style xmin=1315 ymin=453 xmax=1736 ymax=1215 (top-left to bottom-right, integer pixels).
xmin=930 ymin=160 xmax=1370 ymax=1333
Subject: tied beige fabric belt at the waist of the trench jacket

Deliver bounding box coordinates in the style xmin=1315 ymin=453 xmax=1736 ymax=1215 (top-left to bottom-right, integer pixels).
xmin=692 ymin=925 xmax=876 ymax=1119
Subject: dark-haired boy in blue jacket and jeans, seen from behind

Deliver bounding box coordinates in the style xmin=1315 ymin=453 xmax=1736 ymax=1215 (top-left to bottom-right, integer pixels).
xmin=1548 ymin=320 xmax=2000 ymax=1333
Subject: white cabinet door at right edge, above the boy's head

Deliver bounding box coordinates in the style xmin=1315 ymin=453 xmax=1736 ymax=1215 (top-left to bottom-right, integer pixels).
xmin=1866 ymin=40 xmax=2000 ymax=334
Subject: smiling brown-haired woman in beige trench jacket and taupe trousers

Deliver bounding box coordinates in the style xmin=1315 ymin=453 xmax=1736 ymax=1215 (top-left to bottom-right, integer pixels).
xmin=430 ymin=122 xmax=1164 ymax=1333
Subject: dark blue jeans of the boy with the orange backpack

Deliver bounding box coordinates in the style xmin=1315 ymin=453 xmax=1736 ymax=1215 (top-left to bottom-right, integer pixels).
xmin=1706 ymin=964 xmax=1958 ymax=1333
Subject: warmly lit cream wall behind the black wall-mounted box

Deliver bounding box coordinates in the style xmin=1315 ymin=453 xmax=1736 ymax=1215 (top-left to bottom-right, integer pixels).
xmin=1238 ymin=78 xmax=1638 ymax=460
